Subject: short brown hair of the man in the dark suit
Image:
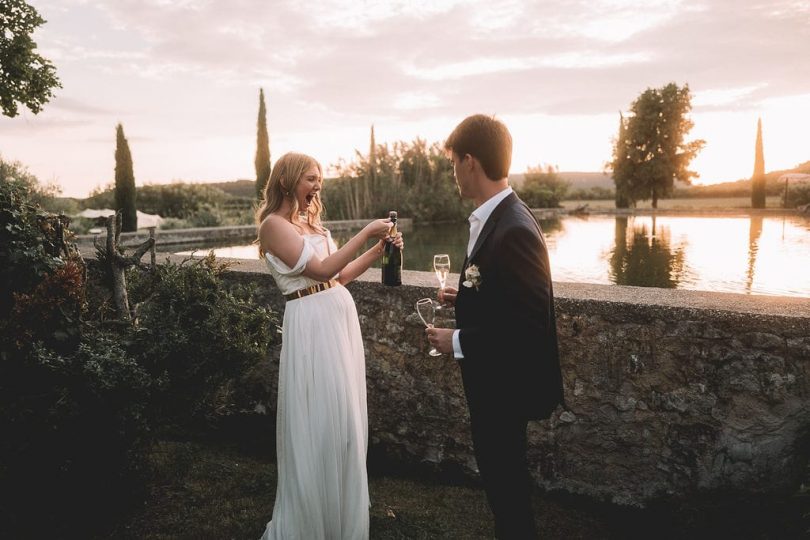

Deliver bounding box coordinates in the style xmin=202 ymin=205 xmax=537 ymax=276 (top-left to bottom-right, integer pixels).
xmin=444 ymin=114 xmax=512 ymax=180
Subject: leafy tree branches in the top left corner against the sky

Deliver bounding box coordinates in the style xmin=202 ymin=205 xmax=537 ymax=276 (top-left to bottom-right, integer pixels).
xmin=0 ymin=0 xmax=62 ymax=117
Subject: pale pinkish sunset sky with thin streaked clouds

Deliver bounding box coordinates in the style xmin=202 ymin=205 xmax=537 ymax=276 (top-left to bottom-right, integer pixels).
xmin=0 ymin=0 xmax=810 ymax=197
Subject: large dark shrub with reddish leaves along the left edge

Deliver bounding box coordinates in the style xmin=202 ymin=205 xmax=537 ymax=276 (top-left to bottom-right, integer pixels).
xmin=0 ymin=179 xmax=150 ymax=537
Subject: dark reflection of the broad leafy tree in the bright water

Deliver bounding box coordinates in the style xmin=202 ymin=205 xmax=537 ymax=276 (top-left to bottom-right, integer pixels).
xmin=610 ymin=217 xmax=684 ymax=289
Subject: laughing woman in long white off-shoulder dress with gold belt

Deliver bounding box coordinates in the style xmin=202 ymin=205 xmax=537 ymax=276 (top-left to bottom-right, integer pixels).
xmin=256 ymin=153 xmax=403 ymax=540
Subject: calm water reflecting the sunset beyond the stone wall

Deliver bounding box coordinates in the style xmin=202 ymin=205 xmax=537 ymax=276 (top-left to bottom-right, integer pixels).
xmin=175 ymin=215 xmax=810 ymax=297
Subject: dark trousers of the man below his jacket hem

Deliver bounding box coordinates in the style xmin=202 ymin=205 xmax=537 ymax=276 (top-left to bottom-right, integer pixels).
xmin=470 ymin=410 xmax=537 ymax=540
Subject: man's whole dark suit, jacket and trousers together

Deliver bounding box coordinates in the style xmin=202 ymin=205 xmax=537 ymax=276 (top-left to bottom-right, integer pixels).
xmin=455 ymin=193 xmax=563 ymax=538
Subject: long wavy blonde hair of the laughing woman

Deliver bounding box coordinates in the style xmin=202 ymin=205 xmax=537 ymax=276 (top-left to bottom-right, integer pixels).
xmin=255 ymin=152 xmax=323 ymax=252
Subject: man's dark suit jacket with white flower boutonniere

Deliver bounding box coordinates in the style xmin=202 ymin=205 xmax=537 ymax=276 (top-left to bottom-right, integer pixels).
xmin=456 ymin=193 xmax=564 ymax=420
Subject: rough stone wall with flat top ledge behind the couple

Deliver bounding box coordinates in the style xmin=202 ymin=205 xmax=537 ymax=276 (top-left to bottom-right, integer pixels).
xmin=211 ymin=261 xmax=810 ymax=506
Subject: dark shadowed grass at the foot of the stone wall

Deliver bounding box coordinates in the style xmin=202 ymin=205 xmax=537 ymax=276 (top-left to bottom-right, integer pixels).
xmin=98 ymin=440 xmax=810 ymax=540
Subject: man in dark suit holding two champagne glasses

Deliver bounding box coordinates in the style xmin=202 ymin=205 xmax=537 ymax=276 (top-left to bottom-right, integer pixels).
xmin=426 ymin=115 xmax=563 ymax=539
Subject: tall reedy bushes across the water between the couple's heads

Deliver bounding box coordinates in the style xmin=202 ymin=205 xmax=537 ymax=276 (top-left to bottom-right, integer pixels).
xmin=322 ymin=139 xmax=472 ymax=222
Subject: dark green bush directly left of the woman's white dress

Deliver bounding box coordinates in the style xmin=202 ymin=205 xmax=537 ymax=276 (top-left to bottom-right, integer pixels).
xmin=127 ymin=253 xmax=276 ymax=424
